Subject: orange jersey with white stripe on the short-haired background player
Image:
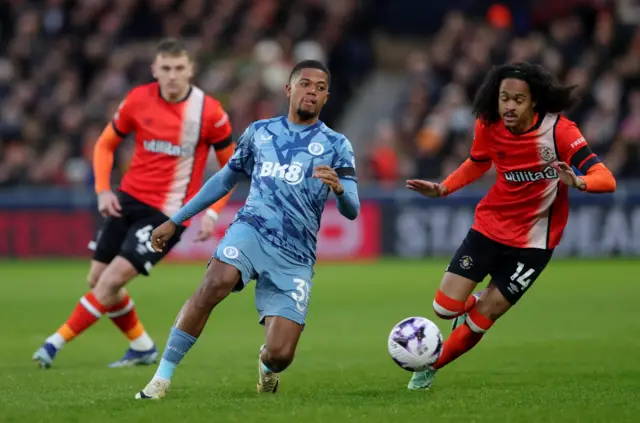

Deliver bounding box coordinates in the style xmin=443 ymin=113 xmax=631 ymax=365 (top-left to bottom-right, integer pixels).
xmin=112 ymin=82 xmax=231 ymax=222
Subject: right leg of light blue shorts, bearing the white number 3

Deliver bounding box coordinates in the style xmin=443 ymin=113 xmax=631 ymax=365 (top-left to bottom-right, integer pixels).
xmin=255 ymin=258 xmax=313 ymax=330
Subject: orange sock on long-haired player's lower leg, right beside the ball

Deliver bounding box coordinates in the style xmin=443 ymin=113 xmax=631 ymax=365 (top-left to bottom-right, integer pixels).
xmin=433 ymin=308 xmax=493 ymax=369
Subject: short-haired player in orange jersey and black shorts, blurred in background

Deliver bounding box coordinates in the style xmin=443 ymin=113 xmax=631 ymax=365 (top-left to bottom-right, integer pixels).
xmin=33 ymin=39 xmax=235 ymax=368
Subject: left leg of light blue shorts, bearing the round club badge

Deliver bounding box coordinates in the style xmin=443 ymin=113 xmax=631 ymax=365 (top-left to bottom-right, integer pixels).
xmin=207 ymin=223 xmax=264 ymax=292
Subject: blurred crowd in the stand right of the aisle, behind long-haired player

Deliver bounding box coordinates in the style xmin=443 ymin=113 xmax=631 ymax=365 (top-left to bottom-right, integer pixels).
xmin=369 ymin=1 xmax=640 ymax=181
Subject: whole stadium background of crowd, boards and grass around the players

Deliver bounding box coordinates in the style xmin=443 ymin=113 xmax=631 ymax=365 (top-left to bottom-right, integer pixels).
xmin=0 ymin=0 xmax=640 ymax=423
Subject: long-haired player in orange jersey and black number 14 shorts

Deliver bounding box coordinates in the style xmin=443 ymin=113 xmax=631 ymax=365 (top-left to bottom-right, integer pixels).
xmin=407 ymin=63 xmax=616 ymax=389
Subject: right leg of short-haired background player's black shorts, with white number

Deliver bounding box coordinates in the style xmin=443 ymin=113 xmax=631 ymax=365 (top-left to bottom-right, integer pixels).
xmin=118 ymin=212 xmax=186 ymax=276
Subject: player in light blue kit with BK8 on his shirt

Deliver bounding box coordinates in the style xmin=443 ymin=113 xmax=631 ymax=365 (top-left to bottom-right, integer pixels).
xmin=136 ymin=61 xmax=360 ymax=399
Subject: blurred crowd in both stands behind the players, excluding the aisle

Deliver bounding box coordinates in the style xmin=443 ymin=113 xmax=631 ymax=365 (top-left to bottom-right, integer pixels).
xmin=0 ymin=0 xmax=640 ymax=186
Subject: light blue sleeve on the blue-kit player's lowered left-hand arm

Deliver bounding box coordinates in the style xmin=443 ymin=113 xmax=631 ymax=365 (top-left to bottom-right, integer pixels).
xmin=171 ymin=165 xmax=243 ymax=225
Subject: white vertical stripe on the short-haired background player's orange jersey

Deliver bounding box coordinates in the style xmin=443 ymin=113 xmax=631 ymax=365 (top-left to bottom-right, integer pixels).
xmin=162 ymin=86 xmax=205 ymax=216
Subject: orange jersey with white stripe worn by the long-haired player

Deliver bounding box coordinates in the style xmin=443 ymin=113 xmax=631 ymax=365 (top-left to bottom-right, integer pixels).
xmin=471 ymin=114 xmax=598 ymax=249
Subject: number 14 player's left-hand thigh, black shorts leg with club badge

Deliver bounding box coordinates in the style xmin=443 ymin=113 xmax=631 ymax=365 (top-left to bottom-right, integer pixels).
xmin=440 ymin=229 xmax=498 ymax=301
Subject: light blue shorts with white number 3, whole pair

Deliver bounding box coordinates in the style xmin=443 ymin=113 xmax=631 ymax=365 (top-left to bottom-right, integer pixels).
xmin=213 ymin=222 xmax=313 ymax=325
